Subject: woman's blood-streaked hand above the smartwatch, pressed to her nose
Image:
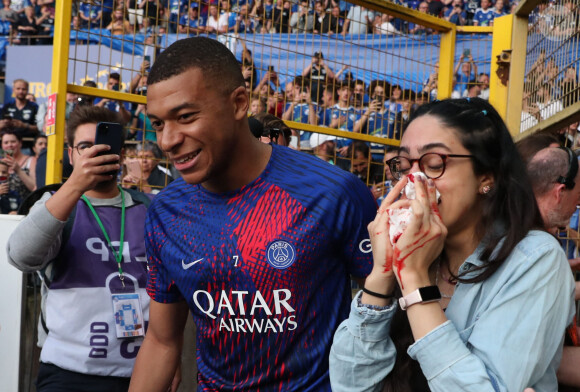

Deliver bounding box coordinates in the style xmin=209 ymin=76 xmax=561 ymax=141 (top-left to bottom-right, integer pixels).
xmin=393 ymin=176 xmax=447 ymax=295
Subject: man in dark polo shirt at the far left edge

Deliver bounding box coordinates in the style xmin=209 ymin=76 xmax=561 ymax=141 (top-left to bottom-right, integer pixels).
xmin=0 ymin=79 xmax=38 ymax=137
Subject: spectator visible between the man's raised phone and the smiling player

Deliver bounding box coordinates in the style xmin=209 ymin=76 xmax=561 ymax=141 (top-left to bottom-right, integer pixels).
xmin=123 ymin=142 xmax=173 ymax=193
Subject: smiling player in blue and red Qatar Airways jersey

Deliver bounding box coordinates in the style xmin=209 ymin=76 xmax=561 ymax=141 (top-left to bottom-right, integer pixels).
xmin=131 ymin=37 xmax=376 ymax=392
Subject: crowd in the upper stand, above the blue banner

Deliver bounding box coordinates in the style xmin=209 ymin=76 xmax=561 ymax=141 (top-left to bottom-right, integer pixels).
xmin=0 ymin=0 xmax=536 ymax=45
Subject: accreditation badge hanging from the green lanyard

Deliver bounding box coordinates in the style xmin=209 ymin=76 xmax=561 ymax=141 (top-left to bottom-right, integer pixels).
xmin=111 ymin=293 xmax=145 ymax=338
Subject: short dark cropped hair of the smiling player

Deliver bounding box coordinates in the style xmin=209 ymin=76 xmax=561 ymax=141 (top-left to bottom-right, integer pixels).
xmin=147 ymin=37 xmax=246 ymax=93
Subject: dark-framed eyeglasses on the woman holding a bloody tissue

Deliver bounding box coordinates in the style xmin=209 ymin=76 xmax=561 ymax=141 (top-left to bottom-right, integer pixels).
xmin=385 ymin=152 xmax=473 ymax=180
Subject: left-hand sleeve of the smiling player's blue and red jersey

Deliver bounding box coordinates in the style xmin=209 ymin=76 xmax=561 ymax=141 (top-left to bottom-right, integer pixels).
xmin=145 ymin=203 xmax=183 ymax=303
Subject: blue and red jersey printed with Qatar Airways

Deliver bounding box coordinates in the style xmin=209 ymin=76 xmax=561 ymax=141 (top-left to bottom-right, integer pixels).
xmin=146 ymin=145 xmax=377 ymax=391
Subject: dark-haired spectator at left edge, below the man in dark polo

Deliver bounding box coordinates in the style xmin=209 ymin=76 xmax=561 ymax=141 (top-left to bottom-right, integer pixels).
xmin=1 ymin=131 xmax=36 ymax=207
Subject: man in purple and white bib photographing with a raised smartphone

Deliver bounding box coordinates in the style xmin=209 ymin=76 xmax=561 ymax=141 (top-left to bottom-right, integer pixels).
xmin=7 ymin=106 xmax=176 ymax=392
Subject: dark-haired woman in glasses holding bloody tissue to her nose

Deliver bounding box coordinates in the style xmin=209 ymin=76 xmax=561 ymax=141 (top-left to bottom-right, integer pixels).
xmin=330 ymin=98 xmax=574 ymax=392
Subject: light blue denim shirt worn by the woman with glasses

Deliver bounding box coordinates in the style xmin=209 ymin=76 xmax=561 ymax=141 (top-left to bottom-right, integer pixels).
xmin=330 ymin=231 xmax=575 ymax=392
